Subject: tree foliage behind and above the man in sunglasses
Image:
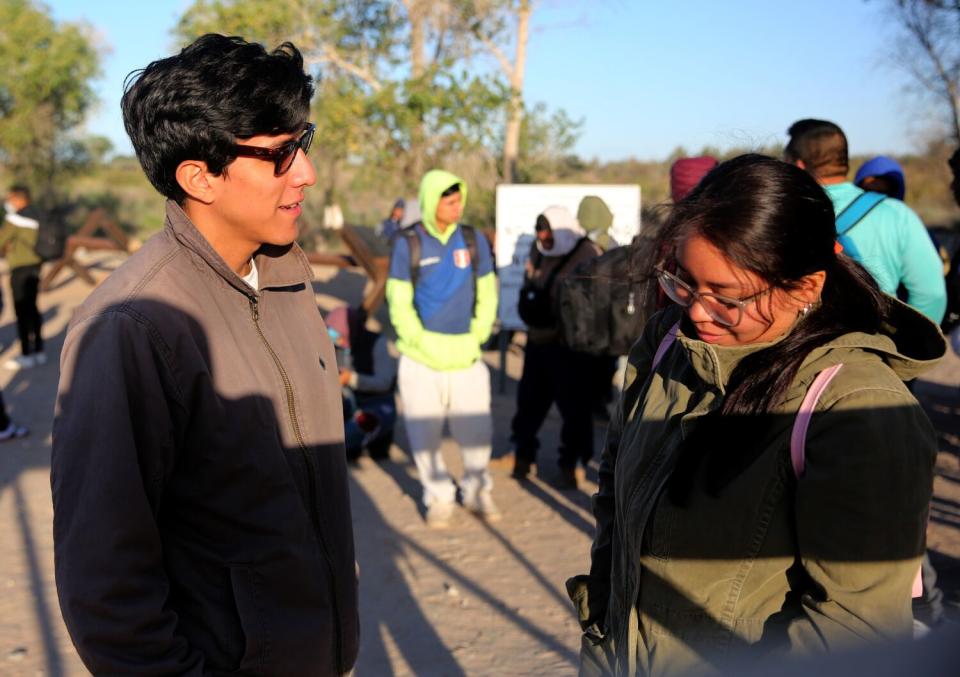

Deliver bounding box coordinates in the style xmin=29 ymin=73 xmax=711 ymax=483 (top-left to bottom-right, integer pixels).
xmin=176 ymin=0 xmax=506 ymax=202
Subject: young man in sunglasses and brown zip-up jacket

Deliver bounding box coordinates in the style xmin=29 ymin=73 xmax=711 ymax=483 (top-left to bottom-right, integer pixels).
xmin=51 ymin=35 xmax=358 ymax=675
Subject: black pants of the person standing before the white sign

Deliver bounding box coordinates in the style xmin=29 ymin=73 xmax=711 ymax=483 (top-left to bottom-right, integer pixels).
xmin=511 ymin=343 xmax=596 ymax=468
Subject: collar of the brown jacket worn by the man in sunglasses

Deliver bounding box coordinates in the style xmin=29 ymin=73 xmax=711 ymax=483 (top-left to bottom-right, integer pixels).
xmin=166 ymin=200 xmax=313 ymax=296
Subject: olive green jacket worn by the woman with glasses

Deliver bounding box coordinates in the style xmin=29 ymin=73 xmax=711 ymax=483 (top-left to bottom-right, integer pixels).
xmin=568 ymin=303 xmax=945 ymax=675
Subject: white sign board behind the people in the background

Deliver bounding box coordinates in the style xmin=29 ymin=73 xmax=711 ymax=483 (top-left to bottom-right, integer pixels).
xmin=496 ymin=184 xmax=640 ymax=330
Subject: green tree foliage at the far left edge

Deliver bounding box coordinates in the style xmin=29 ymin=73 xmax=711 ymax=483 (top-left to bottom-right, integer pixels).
xmin=0 ymin=0 xmax=100 ymax=195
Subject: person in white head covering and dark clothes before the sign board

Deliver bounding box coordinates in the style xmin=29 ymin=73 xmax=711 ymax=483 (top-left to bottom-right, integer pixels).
xmin=510 ymin=207 xmax=610 ymax=489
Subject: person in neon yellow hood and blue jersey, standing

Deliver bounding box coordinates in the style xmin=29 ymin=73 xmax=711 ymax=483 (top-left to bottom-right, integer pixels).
xmin=387 ymin=169 xmax=500 ymax=527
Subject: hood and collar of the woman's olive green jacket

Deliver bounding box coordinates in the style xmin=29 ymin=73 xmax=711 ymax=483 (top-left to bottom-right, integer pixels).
xmin=663 ymin=299 xmax=947 ymax=392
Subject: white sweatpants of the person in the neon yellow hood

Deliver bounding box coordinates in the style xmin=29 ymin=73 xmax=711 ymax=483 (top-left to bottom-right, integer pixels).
xmin=397 ymin=355 xmax=493 ymax=507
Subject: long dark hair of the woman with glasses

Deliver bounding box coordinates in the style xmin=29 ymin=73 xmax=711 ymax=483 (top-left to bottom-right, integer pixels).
xmin=657 ymin=155 xmax=890 ymax=502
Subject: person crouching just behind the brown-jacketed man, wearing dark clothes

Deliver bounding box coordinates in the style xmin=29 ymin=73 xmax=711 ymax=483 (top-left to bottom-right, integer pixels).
xmin=326 ymin=306 xmax=398 ymax=462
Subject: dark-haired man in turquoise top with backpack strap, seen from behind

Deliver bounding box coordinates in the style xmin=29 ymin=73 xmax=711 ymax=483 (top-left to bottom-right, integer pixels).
xmin=784 ymin=119 xmax=947 ymax=324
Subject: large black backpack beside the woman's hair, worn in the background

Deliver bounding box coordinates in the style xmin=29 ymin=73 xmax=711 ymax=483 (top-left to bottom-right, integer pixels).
xmin=556 ymin=240 xmax=652 ymax=356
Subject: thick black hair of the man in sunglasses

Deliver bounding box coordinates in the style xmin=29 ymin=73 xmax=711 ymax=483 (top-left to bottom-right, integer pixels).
xmin=121 ymin=33 xmax=313 ymax=203
